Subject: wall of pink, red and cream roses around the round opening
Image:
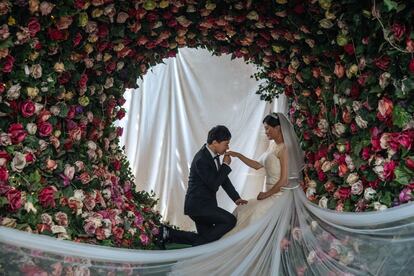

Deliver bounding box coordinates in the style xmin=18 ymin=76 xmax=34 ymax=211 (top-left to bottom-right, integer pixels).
xmin=0 ymin=0 xmax=414 ymax=248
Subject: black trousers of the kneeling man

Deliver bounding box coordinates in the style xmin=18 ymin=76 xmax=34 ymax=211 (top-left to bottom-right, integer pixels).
xmin=169 ymin=207 xmax=237 ymax=246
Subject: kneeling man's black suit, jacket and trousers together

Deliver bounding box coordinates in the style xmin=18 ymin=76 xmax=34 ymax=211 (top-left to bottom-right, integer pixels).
xmin=184 ymin=145 xmax=240 ymax=245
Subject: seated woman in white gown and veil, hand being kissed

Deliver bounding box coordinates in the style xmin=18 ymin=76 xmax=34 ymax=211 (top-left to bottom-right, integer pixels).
xmin=225 ymin=113 xmax=303 ymax=237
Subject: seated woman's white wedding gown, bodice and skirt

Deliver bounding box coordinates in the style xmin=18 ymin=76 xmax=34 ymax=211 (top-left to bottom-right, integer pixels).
xmin=224 ymin=142 xmax=285 ymax=237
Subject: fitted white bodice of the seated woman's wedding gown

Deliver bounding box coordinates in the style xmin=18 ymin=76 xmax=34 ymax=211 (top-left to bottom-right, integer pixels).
xmin=258 ymin=142 xmax=285 ymax=185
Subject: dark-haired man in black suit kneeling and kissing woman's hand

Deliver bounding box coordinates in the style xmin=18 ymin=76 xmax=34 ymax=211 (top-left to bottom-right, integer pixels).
xmin=159 ymin=125 xmax=247 ymax=246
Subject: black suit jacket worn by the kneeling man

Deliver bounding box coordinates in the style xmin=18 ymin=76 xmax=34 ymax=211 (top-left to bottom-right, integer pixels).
xmin=184 ymin=145 xmax=240 ymax=216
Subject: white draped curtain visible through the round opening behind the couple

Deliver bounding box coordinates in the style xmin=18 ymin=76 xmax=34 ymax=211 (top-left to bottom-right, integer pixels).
xmin=118 ymin=48 xmax=287 ymax=230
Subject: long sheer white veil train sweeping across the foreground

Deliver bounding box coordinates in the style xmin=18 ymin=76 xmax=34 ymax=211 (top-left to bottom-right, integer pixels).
xmin=0 ymin=189 xmax=414 ymax=275
